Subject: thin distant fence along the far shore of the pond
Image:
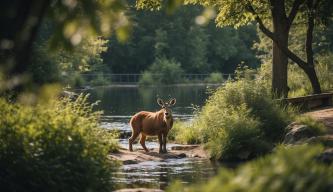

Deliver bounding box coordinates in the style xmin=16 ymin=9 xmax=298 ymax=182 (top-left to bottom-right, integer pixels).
xmin=81 ymin=73 xmax=234 ymax=84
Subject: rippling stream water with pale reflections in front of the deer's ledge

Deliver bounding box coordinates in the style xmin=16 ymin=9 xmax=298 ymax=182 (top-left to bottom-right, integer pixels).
xmin=113 ymin=158 xmax=217 ymax=189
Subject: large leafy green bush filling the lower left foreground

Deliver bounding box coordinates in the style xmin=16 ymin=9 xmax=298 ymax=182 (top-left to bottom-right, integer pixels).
xmin=0 ymin=96 xmax=118 ymax=191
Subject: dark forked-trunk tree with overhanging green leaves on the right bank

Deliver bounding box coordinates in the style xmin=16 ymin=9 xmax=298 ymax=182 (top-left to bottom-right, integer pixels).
xmin=185 ymin=0 xmax=331 ymax=97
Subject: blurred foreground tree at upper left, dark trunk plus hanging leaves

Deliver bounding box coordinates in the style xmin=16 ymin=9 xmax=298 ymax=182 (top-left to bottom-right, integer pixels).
xmin=0 ymin=0 xmax=130 ymax=89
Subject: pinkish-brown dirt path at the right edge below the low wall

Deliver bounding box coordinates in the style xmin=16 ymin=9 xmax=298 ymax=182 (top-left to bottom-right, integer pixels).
xmin=306 ymin=107 xmax=333 ymax=135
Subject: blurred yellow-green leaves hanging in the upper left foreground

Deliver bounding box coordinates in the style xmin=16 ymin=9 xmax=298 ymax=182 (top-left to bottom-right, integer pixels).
xmin=48 ymin=0 xmax=130 ymax=46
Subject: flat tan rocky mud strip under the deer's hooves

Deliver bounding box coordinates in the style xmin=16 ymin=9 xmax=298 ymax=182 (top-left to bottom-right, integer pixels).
xmin=110 ymin=145 xmax=208 ymax=164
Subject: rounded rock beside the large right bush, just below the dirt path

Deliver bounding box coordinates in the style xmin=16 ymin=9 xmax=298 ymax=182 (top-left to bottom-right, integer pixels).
xmin=283 ymin=122 xmax=315 ymax=144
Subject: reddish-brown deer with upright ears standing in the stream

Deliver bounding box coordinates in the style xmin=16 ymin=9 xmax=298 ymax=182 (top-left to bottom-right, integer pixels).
xmin=128 ymin=98 xmax=176 ymax=153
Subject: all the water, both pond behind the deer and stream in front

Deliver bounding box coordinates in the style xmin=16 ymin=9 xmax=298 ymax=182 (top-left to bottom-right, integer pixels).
xmin=80 ymin=86 xmax=217 ymax=189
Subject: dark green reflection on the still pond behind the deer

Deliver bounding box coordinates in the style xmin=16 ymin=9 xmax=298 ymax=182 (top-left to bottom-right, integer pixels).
xmin=81 ymin=86 xmax=214 ymax=116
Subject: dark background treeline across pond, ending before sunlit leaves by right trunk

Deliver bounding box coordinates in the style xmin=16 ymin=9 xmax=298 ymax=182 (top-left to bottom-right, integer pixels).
xmin=30 ymin=6 xmax=260 ymax=87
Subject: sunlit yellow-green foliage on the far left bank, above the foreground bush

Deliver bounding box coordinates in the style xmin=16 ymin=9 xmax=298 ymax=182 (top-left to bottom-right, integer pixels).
xmin=29 ymin=22 xmax=108 ymax=87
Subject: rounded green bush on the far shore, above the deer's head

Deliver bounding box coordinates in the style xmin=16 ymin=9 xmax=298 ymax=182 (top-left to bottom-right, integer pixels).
xmin=140 ymin=57 xmax=183 ymax=85
